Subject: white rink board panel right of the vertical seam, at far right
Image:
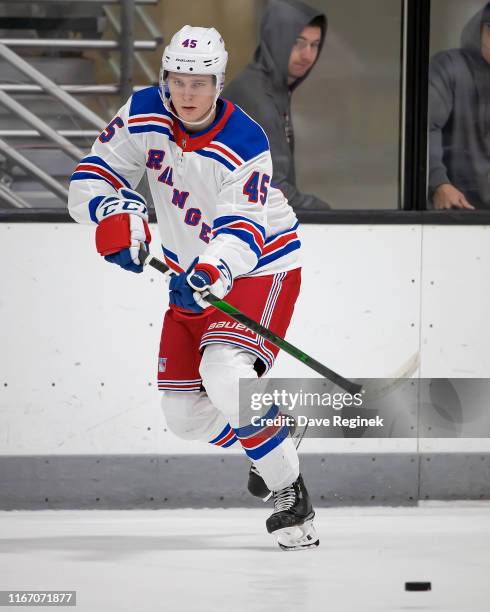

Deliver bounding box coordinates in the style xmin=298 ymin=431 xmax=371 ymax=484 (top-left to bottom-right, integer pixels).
xmin=419 ymin=226 xmax=490 ymax=453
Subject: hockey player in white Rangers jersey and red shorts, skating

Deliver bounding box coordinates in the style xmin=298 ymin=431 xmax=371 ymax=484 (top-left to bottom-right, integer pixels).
xmin=69 ymin=26 xmax=318 ymax=549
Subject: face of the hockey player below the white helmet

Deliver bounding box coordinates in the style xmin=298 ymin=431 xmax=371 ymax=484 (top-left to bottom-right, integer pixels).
xmin=167 ymin=72 xmax=216 ymax=123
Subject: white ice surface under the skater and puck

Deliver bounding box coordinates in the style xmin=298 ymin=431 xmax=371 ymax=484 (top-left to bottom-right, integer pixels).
xmin=0 ymin=503 xmax=490 ymax=612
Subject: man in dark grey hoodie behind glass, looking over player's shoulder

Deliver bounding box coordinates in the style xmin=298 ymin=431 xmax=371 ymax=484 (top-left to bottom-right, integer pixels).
xmin=223 ymin=0 xmax=330 ymax=210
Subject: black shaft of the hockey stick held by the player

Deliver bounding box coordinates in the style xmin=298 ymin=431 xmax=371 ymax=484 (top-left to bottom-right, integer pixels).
xmin=139 ymin=247 xmax=362 ymax=395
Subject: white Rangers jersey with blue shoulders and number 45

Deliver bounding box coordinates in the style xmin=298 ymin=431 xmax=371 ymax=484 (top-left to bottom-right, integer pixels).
xmin=69 ymin=87 xmax=300 ymax=277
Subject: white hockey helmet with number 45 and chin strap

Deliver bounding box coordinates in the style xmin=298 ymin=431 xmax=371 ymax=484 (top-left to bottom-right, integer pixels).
xmin=160 ymin=26 xmax=228 ymax=125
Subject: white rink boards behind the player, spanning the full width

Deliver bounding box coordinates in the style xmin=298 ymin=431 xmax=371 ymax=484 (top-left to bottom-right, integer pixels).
xmin=0 ymin=223 xmax=490 ymax=455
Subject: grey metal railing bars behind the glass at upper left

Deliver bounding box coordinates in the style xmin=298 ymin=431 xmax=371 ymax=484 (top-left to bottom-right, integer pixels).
xmin=0 ymin=0 xmax=163 ymax=208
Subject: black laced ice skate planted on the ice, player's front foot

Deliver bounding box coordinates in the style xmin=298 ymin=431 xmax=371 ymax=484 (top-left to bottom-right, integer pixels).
xmin=265 ymin=474 xmax=320 ymax=550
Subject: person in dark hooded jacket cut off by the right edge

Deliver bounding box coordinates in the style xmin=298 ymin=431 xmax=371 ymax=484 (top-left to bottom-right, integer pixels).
xmin=429 ymin=2 xmax=490 ymax=210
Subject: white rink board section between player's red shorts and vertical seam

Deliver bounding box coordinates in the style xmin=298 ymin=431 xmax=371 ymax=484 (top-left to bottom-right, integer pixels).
xmin=280 ymin=225 xmax=421 ymax=378
